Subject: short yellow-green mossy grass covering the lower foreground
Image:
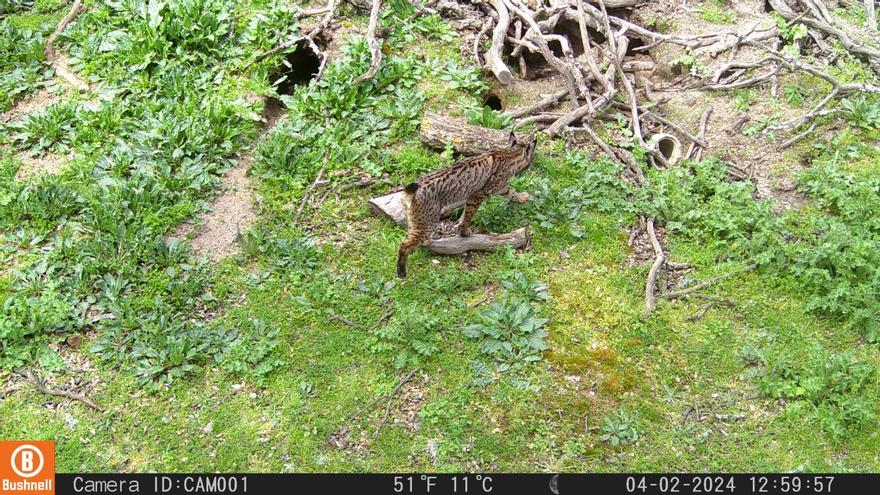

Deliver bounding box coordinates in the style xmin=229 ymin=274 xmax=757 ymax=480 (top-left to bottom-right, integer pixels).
xmin=0 ymin=0 xmax=880 ymax=471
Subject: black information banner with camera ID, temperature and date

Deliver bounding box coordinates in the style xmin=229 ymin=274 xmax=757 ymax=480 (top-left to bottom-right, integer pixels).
xmin=56 ymin=474 xmax=880 ymax=495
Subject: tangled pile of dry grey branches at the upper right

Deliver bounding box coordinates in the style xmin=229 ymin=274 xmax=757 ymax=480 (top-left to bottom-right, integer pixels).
xmin=458 ymin=0 xmax=880 ymax=313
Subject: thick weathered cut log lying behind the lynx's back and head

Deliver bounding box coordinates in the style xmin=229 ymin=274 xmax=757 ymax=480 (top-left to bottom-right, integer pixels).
xmin=419 ymin=113 xmax=509 ymax=156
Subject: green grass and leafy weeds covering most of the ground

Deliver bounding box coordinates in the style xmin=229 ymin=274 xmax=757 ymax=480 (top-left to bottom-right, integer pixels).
xmin=0 ymin=0 xmax=880 ymax=472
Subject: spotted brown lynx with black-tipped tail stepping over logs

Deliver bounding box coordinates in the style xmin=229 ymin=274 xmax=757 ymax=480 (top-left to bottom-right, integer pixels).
xmin=397 ymin=132 xmax=536 ymax=278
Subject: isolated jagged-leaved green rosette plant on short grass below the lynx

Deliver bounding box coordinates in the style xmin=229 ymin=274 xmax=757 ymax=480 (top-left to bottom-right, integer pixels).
xmin=462 ymin=299 xmax=548 ymax=371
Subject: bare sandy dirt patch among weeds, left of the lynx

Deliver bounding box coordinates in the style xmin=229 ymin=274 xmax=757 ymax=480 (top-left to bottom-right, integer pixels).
xmin=172 ymin=156 xmax=257 ymax=261
